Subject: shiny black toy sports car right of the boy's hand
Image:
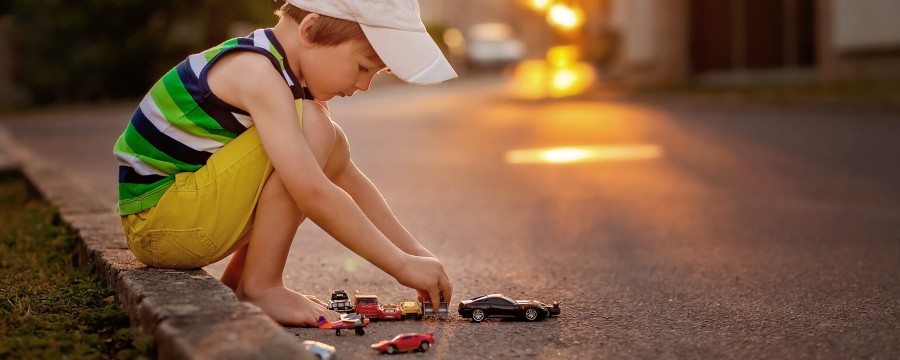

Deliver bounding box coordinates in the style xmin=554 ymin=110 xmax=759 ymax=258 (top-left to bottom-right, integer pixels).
xmin=459 ymin=294 xmax=559 ymax=322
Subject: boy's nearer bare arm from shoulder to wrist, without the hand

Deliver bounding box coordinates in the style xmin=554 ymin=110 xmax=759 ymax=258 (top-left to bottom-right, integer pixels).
xmin=216 ymin=53 xmax=408 ymax=277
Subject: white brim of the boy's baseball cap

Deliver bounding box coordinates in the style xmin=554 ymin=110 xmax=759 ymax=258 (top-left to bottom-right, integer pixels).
xmin=360 ymin=24 xmax=457 ymax=85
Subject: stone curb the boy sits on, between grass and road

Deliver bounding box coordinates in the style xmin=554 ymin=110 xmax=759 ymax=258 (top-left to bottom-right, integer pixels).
xmin=0 ymin=124 xmax=305 ymax=359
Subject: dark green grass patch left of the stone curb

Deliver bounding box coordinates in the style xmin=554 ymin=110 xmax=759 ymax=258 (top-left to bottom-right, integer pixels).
xmin=0 ymin=174 xmax=155 ymax=359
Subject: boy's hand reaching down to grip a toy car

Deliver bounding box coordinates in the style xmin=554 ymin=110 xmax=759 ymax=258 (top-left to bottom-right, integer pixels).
xmin=396 ymin=255 xmax=453 ymax=313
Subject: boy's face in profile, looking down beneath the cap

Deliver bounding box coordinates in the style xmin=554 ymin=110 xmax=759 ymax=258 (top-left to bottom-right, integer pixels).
xmin=301 ymin=40 xmax=385 ymax=101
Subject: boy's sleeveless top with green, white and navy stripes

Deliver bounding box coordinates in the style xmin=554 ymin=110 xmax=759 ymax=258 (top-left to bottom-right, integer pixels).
xmin=113 ymin=29 xmax=312 ymax=215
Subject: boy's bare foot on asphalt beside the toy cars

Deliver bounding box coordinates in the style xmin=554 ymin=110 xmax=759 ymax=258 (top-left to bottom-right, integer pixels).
xmin=235 ymin=285 xmax=341 ymax=327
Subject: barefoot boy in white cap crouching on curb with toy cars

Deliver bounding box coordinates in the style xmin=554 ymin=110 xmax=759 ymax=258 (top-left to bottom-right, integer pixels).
xmin=114 ymin=0 xmax=456 ymax=326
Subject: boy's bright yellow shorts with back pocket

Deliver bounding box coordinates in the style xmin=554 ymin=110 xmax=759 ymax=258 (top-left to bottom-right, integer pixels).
xmin=122 ymin=125 xmax=272 ymax=269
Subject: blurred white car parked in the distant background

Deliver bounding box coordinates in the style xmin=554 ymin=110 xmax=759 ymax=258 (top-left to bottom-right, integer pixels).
xmin=465 ymin=23 xmax=525 ymax=69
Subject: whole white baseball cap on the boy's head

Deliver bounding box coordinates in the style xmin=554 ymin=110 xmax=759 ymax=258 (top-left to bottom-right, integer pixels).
xmin=287 ymin=0 xmax=457 ymax=85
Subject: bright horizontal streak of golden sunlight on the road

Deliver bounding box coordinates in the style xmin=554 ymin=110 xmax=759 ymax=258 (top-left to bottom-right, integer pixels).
xmin=505 ymin=144 xmax=663 ymax=164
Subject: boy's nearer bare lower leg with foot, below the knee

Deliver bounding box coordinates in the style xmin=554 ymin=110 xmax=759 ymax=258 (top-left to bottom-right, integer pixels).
xmin=232 ymin=172 xmax=339 ymax=326
